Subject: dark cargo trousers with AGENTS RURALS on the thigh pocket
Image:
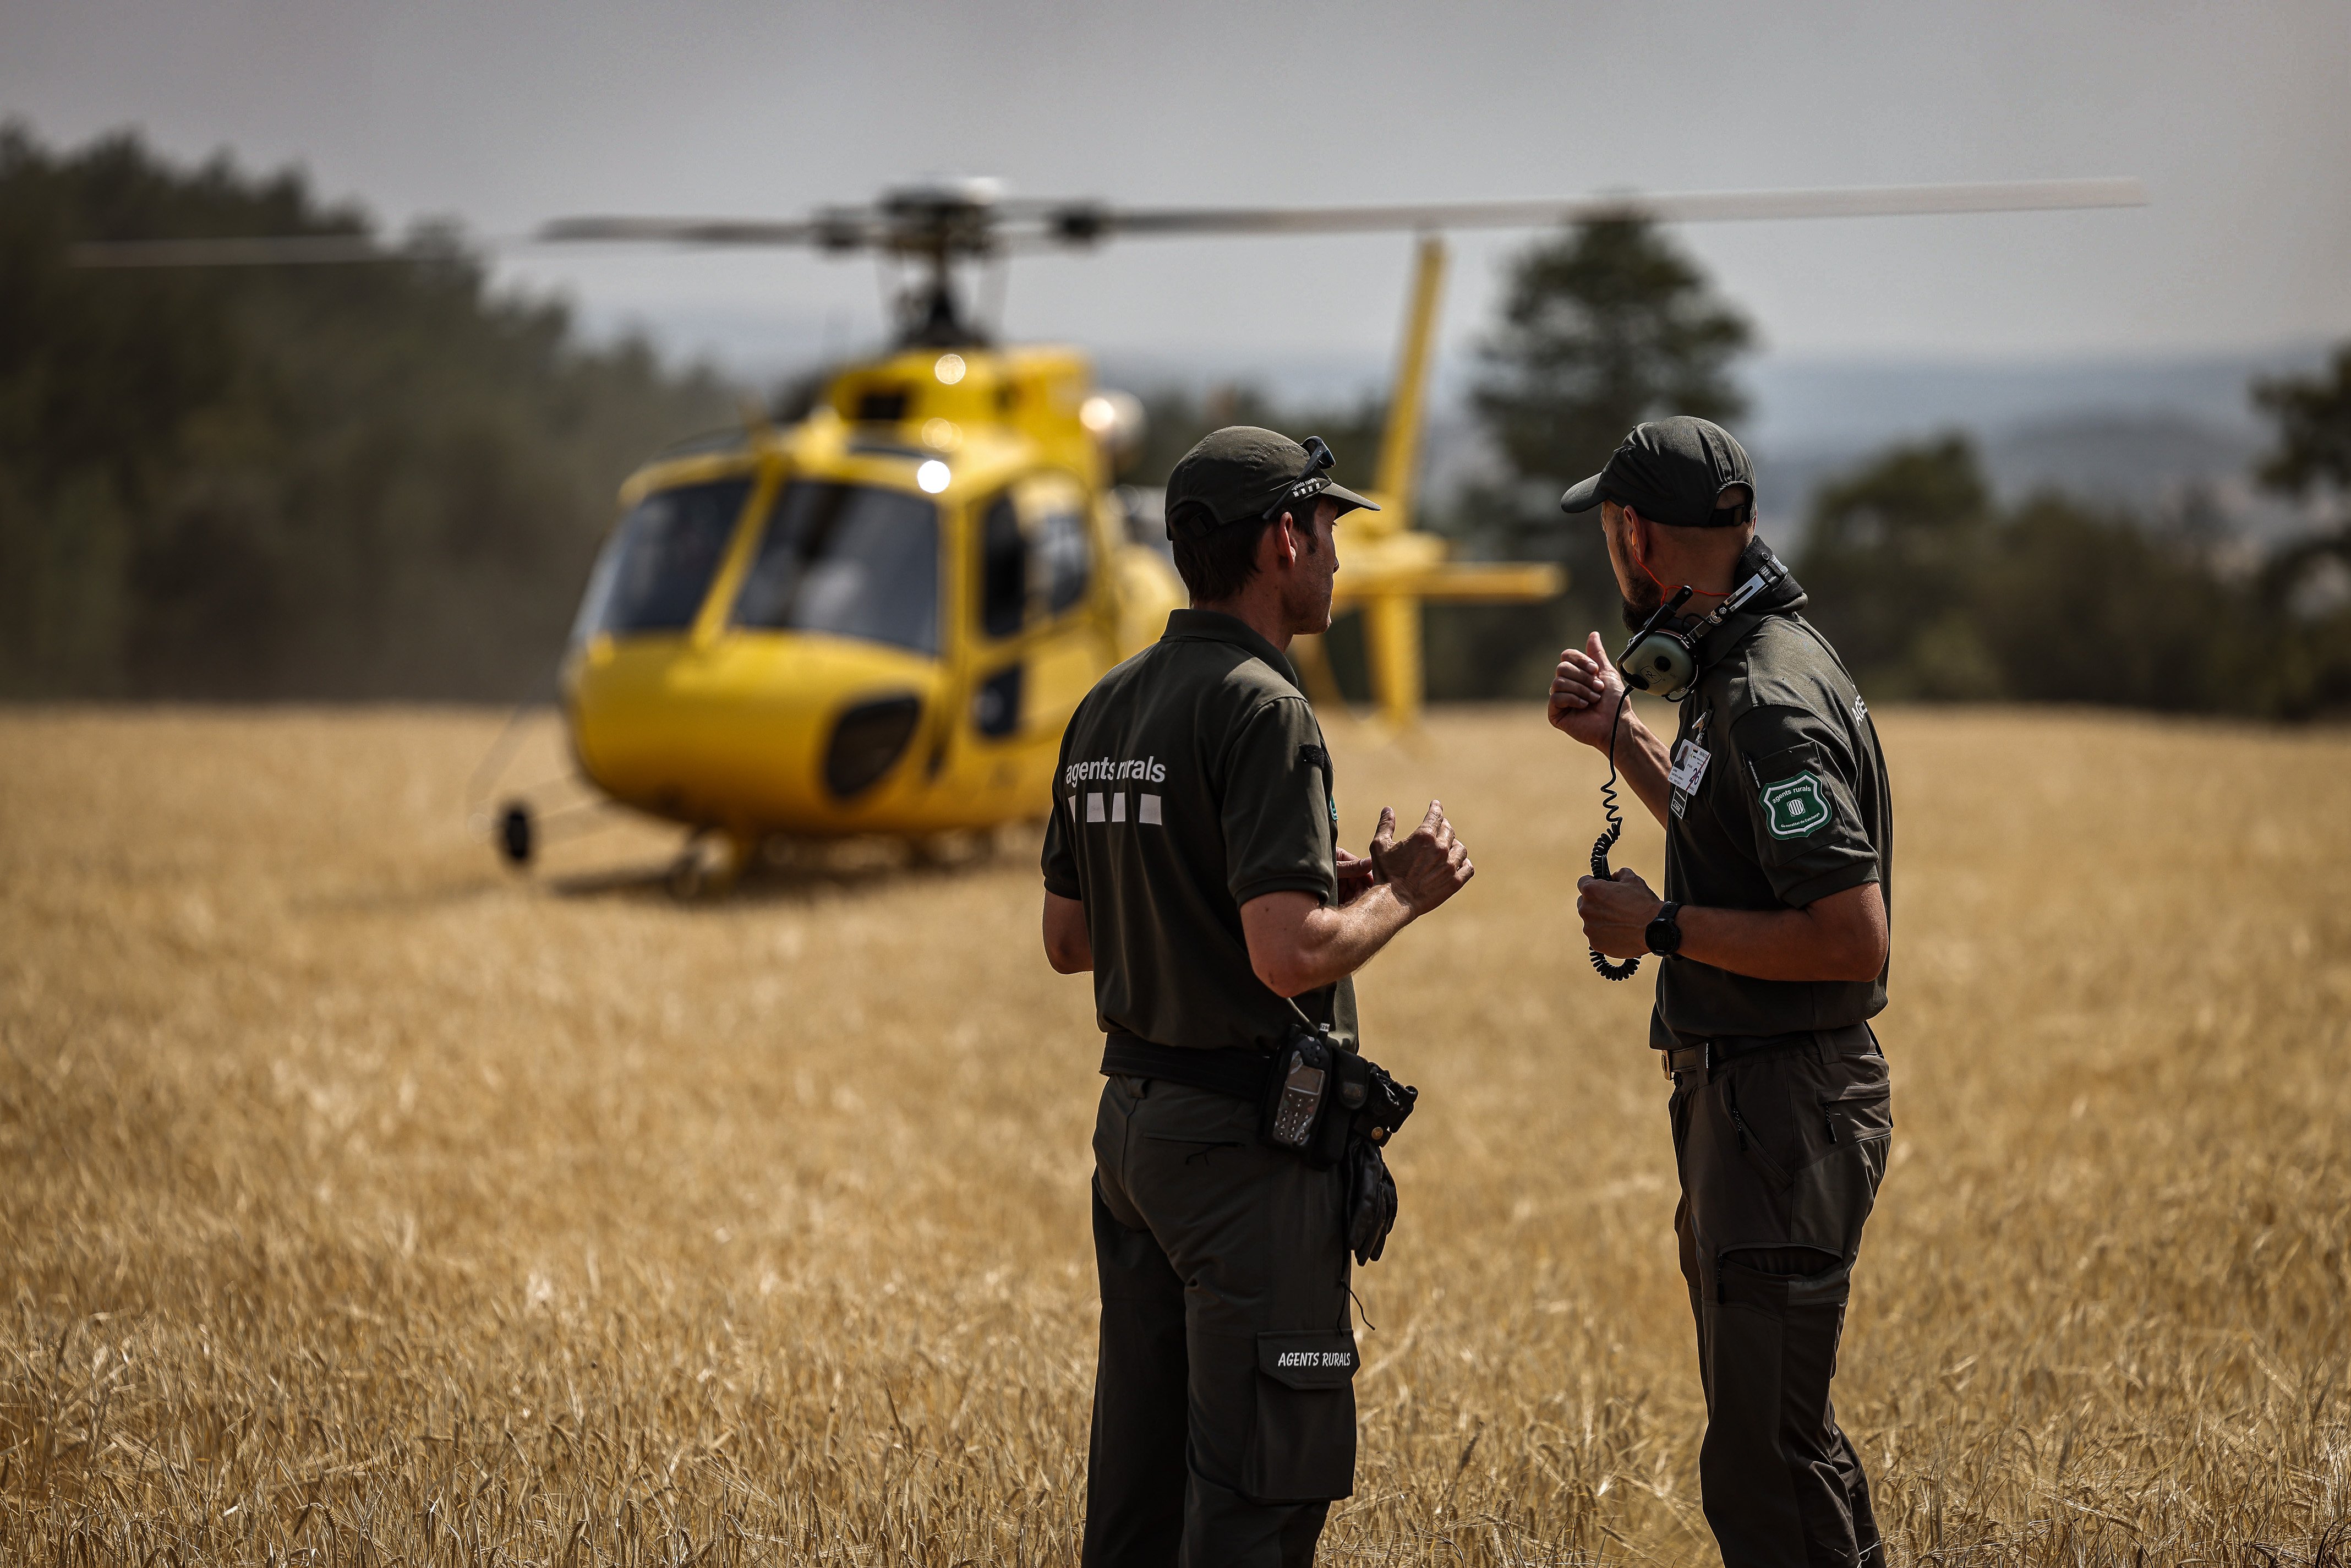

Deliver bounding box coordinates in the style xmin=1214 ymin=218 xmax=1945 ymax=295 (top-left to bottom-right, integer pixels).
xmin=1084 ymin=1079 xmax=1354 ymax=1568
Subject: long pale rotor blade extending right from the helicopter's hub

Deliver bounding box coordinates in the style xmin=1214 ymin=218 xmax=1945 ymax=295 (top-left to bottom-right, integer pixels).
xmin=1048 ymin=179 xmax=2146 ymax=242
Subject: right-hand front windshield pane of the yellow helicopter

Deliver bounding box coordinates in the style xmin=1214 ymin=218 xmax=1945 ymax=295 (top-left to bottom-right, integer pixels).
xmin=734 ymin=479 xmax=938 ymax=653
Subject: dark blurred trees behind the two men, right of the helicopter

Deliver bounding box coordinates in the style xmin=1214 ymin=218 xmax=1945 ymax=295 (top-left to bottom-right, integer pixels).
xmin=1155 ymin=221 xmax=2351 ymax=719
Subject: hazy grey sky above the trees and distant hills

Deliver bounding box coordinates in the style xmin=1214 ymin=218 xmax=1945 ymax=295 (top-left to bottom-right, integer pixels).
xmin=0 ymin=0 xmax=2351 ymax=392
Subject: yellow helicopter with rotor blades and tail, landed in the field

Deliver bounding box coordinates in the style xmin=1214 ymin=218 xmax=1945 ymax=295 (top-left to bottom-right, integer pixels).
xmin=80 ymin=179 xmax=2144 ymax=875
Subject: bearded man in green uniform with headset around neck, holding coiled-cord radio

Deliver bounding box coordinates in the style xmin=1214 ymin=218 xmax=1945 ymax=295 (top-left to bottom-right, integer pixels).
xmin=1549 ymin=418 xmax=1893 ymax=1568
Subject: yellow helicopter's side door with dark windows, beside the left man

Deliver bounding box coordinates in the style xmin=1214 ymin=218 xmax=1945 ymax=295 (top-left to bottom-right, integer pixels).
xmin=971 ymin=473 xmax=1107 ymax=745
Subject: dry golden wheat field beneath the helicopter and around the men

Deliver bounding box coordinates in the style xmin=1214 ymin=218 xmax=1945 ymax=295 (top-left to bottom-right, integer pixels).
xmin=0 ymin=708 xmax=2351 ymax=1566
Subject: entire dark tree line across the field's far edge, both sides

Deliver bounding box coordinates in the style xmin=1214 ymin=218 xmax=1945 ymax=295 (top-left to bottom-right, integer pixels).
xmin=0 ymin=124 xmax=2351 ymax=717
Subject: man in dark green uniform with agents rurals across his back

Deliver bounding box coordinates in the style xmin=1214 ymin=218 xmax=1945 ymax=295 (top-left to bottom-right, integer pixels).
xmin=1044 ymin=425 xmax=1474 ymax=1568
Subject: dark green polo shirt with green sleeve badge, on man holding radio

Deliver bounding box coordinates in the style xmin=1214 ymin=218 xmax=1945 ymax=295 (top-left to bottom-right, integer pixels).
xmin=1650 ymin=557 xmax=1895 ymax=1051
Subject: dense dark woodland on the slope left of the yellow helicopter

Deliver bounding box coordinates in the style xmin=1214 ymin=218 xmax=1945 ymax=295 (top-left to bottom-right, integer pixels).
xmin=0 ymin=124 xmax=736 ymax=698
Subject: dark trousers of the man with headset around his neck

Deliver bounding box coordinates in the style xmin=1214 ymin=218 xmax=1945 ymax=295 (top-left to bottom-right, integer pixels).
xmin=1671 ymin=1034 xmax=1893 ymax=1568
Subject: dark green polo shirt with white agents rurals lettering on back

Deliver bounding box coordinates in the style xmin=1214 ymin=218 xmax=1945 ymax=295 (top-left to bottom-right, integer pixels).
xmin=1044 ymin=609 xmax=1354 ymax=1051
